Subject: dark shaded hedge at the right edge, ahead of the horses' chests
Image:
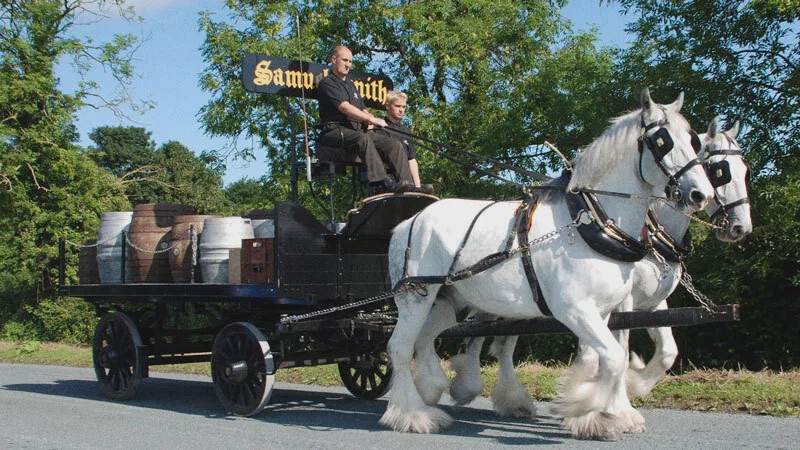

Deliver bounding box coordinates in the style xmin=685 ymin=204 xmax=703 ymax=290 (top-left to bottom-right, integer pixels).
xmin=670 ymin=153 xmax=800 ymax=370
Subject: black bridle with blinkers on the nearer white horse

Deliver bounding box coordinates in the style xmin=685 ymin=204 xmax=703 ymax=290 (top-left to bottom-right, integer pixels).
xmin=639 ymin=107 xmax=703 ymax=203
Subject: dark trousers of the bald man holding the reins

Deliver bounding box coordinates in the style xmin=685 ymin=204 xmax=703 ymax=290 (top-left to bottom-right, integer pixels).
xmin=317 ymin=124 xmax=414 ymax=184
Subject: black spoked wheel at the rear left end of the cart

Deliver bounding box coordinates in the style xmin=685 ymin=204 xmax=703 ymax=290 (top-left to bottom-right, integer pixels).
xmin=92 ymin=312 xmax=143 ymax=400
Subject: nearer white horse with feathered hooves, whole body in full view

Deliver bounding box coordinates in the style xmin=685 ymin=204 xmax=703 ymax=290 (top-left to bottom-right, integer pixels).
xmin=380 ymin=90 xmax=713 ymax=439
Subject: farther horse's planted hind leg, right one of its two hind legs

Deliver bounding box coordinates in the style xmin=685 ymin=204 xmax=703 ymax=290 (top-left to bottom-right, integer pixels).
xmin=489 ymin=336 xmax=536 ymax=417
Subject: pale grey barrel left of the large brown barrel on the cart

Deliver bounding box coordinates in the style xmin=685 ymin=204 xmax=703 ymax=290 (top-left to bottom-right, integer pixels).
xmin=97 ymin=211 xmax=133 ymax=284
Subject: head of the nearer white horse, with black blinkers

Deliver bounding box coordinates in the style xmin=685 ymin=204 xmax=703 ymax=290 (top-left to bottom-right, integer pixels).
xmin=639 ymin=88 xmax=714 ymax=212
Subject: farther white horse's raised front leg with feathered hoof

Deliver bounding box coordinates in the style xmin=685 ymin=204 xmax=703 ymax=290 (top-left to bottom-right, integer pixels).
xmin=626 ymin=300 xmax=678 ymax=397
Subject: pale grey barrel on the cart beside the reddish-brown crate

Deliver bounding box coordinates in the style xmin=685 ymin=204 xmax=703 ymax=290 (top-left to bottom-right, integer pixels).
xmin=200 ymin=217 xmax=253 ymax=284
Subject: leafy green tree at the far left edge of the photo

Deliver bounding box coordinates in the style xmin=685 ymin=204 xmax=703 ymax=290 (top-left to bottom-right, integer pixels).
xmin=0 ymin=0 xmax=138 ymax=338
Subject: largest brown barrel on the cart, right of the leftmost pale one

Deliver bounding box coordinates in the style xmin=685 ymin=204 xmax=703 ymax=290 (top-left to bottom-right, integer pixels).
xmin=128 ymin=203 xmax=193 ymax=283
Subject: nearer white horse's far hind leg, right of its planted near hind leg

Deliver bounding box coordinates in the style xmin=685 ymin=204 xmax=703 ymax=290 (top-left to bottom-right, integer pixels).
xmin=414 ymin=296 xmax=457 ymax=406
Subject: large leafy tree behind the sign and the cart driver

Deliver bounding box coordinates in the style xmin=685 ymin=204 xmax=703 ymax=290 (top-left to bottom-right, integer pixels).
xmin=201 ymin=0 xmax=628 ymax=203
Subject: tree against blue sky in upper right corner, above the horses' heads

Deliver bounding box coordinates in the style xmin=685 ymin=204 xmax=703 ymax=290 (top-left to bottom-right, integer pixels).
xmin=608 ymin=0 xmax=800 ymax=175
